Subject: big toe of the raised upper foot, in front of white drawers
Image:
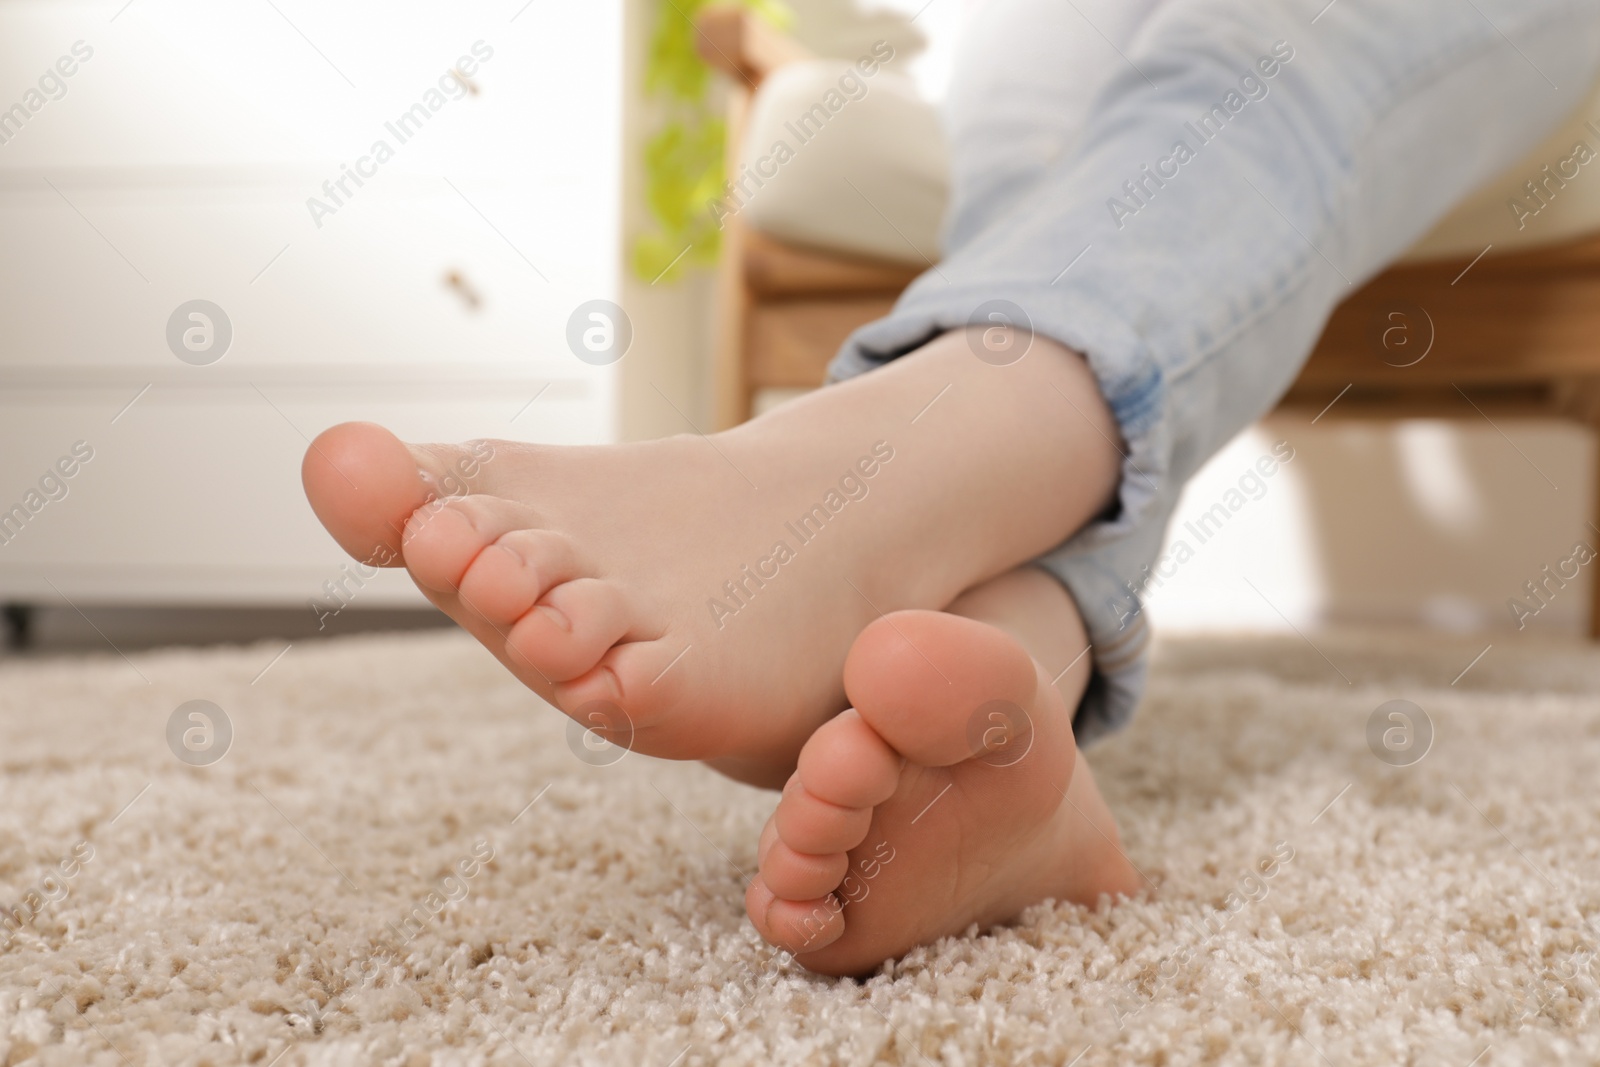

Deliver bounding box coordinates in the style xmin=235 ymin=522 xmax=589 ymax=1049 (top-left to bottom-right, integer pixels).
xmin=301 ymin=422 xmax=430 ymax=566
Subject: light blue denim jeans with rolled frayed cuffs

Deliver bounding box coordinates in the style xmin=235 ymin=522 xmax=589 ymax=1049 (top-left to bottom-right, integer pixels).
xmin=830 ymin=0 xmax=1600 ymax=741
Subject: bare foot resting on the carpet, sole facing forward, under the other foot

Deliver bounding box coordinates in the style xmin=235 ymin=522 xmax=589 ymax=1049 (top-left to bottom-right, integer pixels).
xmin=746 ymin=604 xmax=1139 ymax=974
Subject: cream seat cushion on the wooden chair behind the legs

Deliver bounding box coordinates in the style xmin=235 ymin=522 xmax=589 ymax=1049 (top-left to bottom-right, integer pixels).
xmin=742 ymin=59 xmax=1600 ymax=266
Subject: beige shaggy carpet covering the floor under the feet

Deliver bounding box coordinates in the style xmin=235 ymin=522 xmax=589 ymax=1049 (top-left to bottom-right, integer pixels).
xmin=0 ymin=633 xmax=1600 ymax=1067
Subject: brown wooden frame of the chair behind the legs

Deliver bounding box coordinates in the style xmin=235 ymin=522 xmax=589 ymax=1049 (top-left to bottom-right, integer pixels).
xmin=698 ymin=6 xmax=1600 ymax=638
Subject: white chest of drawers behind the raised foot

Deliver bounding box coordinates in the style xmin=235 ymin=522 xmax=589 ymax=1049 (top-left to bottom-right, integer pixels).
xmin=0 ymin=0 xmax=622 ymax=605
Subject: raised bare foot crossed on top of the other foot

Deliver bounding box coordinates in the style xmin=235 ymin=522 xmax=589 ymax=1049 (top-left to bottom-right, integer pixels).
xmin=302 ymin=334 xmax=1118 ymax=787
